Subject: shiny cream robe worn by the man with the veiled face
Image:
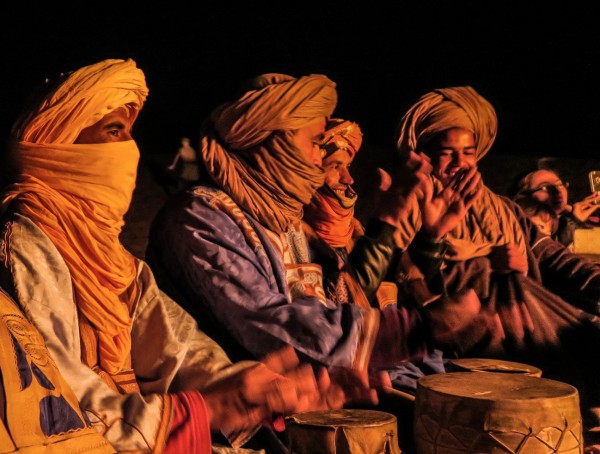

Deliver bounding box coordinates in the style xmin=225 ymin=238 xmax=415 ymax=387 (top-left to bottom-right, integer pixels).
xmin=0 ymin=215 xmax=241 ymax=452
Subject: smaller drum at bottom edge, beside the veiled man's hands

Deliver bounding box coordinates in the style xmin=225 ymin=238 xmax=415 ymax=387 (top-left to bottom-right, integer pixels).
xmin=285 ymin=409 xmax=400 ymax=454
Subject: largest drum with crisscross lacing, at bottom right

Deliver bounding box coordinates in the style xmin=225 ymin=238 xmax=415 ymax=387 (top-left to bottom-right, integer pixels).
xmin=414 ymin=372 xmax=583 ymax=454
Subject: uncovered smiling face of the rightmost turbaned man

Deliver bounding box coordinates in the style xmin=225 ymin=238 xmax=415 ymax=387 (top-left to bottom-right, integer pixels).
xmin=427 ymin=128 xmax=477 ymax=185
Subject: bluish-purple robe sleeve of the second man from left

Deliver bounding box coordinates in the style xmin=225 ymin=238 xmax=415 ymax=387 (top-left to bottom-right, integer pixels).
xmin=147 ymin=193 xmax=375 ymax=367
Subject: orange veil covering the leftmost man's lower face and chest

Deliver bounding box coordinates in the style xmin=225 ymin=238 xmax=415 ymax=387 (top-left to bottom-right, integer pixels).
xmin=2 ymin=141 xmax=139 ymax=374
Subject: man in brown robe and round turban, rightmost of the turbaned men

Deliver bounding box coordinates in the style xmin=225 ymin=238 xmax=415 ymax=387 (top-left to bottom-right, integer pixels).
xmin=397 ymin=86 xmax=600 ymax=446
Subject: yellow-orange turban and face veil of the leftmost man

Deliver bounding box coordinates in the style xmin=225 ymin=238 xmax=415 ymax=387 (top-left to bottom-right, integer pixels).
xmin=1 ymin=59 xmax=148 ymax=375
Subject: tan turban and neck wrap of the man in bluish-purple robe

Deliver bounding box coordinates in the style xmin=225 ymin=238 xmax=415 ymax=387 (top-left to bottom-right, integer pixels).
xmin=200 ymin=74 xmax=337 ymax=232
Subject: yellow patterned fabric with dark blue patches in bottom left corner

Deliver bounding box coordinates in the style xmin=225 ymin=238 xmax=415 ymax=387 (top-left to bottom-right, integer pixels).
xmin=0 ymin=289 xmax=115 ymax=454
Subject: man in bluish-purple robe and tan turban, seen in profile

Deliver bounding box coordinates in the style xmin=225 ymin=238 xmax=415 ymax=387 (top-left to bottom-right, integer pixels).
xmin=146 ymin=74 xmax=490 ymax=454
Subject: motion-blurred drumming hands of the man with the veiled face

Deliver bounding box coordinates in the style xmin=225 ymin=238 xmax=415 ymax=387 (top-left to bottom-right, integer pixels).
xmin=202 ymin=347 xmax=324 ymax=431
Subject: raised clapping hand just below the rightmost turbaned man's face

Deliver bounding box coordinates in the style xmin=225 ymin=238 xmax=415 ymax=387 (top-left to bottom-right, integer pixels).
xmin=419 ymin=167 xmax=483 ymax=240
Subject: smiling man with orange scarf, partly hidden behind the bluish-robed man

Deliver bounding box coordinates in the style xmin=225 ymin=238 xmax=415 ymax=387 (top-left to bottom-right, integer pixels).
xmin=303 ymin=118 xmax=454 ymax=394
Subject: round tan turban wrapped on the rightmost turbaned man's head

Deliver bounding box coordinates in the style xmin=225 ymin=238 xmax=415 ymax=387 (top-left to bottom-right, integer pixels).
xmin=397 ymin=86 xmax=498 ymax=159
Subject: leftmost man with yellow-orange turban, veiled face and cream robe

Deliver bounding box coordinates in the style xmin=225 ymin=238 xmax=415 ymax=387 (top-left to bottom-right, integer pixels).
xmin=0 ymin=59 xmax=342 ymax=453
